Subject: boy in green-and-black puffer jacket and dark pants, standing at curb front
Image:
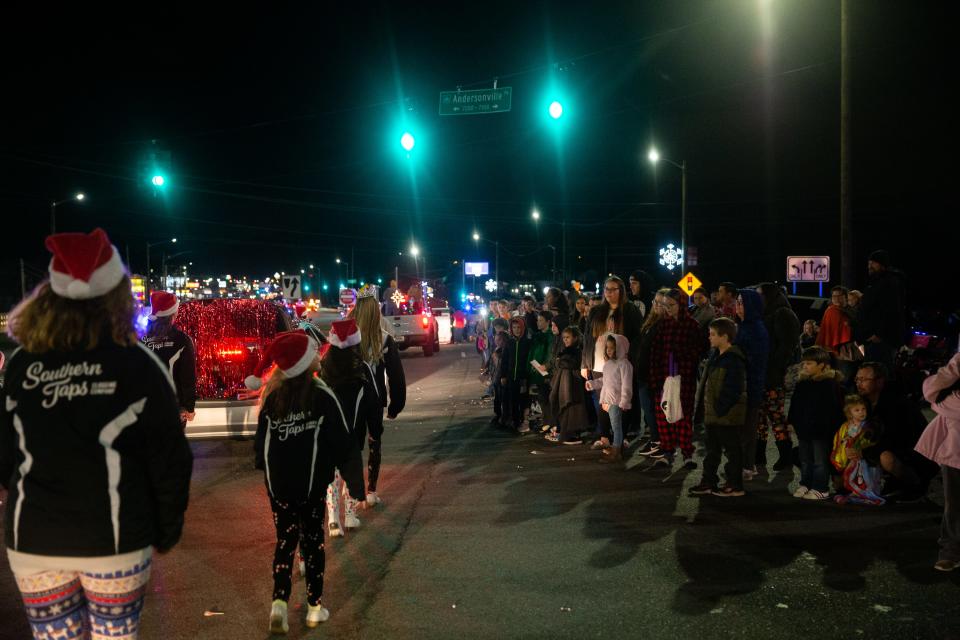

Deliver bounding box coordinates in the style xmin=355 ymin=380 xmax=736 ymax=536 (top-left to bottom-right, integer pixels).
xmin=690 ymin=317 xmax=748 ymax=498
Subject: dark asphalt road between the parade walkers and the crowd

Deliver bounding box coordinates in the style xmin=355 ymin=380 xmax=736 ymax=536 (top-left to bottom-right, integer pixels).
xmin=0 ymin=346 xmax=960 ymax=640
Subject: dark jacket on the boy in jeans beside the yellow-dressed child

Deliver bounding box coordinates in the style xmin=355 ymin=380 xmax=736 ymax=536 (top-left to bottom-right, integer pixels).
xmin=787 ymin=367 xmax=845 ymax=442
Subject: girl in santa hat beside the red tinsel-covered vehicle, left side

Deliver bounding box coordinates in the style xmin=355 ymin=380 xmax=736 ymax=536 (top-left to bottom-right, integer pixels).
xmin=143 ymin=291 xmax=197 ymax=427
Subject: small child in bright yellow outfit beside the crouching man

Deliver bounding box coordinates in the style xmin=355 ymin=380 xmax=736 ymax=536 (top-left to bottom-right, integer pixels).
xmin=830 ymin=395 xmax=886 ymax=506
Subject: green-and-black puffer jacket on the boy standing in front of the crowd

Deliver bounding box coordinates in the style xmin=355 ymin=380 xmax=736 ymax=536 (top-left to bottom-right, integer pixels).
xmin=696 ymin=345 xmax=747 ymax=427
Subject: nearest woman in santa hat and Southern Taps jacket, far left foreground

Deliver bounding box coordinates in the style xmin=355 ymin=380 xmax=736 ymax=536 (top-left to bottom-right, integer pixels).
xmin=0 ymin=229 xmax=193 ymax=638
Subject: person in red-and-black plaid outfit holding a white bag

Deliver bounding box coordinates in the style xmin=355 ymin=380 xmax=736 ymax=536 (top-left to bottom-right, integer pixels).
xmin=650 ymin=289 xmax=706 ymax=468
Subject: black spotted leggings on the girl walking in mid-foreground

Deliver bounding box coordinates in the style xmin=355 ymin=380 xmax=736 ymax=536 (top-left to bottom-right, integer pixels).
xmin=270 ymin=497 xmax=326 ymax=606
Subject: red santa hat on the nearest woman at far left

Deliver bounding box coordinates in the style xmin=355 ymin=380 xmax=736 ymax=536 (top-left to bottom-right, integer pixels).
xmin=45 ymin=229 xmax=126 ymax=300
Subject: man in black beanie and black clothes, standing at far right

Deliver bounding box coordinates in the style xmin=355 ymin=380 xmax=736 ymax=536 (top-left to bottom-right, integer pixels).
xmin=854 ymin=249 xmax=905 ymax=372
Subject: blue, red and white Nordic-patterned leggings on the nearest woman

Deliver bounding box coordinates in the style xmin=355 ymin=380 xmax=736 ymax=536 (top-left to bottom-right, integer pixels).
xmin=17 ymin=558 xmax=150 ymax=640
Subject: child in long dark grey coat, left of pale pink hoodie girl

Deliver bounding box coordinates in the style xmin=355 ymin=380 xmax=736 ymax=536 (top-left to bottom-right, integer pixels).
xmin=546 ymin=326 xmax=588 ymax=444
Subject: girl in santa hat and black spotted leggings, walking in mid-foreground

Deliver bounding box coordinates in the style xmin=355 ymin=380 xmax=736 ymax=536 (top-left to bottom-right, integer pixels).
xmin=245 ymin=331 xmax=364 ymax=633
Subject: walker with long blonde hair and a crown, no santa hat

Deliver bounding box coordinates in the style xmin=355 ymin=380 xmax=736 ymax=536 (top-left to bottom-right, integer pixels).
xmin=349 ymin=288 xmax=407 ymax=507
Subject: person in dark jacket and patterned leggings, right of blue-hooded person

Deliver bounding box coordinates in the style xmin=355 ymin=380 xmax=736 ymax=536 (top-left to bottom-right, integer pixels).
xmin=758 ymin=282 xmax=802 ymax=468
